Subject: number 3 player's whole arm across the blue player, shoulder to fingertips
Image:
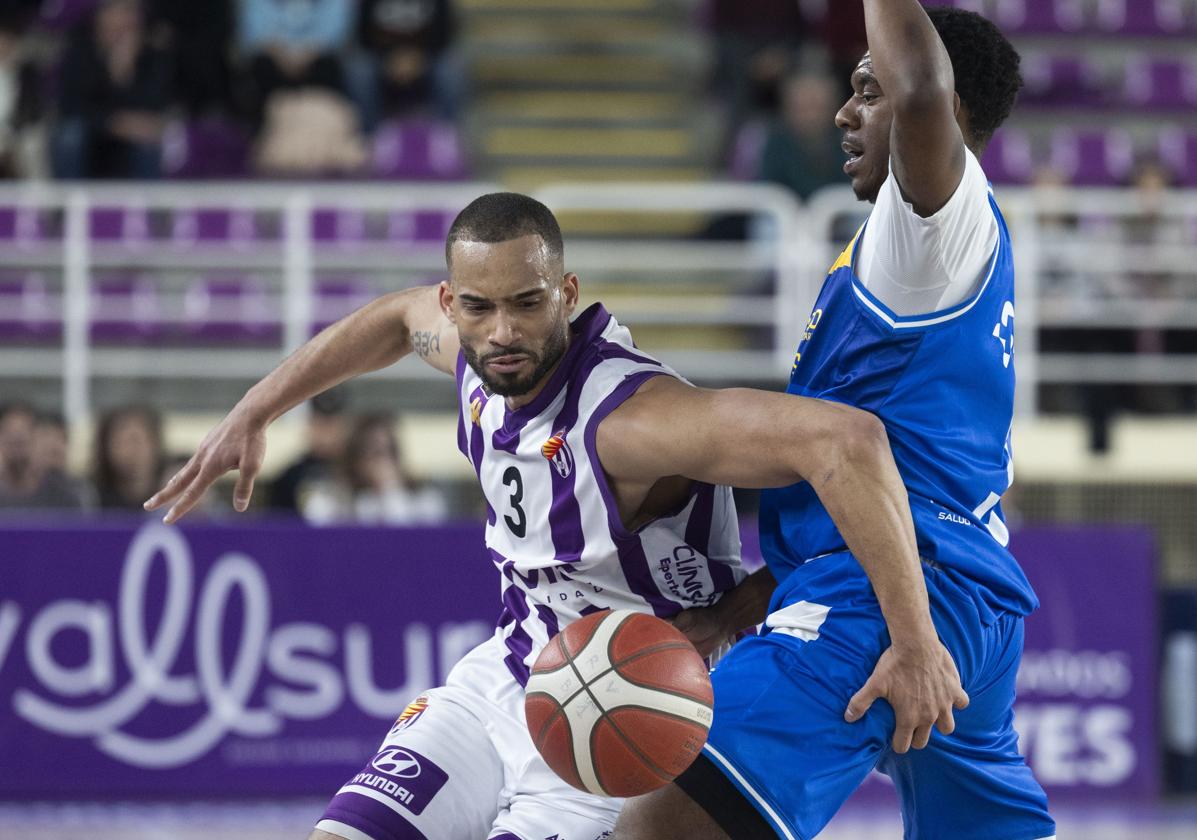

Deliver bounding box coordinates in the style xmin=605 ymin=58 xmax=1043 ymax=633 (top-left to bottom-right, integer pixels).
xmin=597 ymin=377 xmax=968 ymax=753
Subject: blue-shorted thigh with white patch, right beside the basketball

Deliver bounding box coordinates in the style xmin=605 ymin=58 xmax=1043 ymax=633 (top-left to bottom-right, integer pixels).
xmin=678 ymin=598 xmax=893 ymax=839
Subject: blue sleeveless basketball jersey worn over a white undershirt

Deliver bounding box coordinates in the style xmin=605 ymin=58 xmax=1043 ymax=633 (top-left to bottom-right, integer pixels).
xmin=760 ymin=189 xmax=1038 ymax=615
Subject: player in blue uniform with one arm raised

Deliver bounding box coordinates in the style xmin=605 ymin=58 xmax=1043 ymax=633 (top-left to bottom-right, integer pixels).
xmin=615 ymin=0 xmax=1056 ymax=840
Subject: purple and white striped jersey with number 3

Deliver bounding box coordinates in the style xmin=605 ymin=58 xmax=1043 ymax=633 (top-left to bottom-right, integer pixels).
xmin=457 ymin=304 xmax=745 ymax=684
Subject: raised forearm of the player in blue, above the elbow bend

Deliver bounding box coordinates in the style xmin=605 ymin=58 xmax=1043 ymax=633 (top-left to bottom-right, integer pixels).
xmin=864 ymin=0 xmax=955 ymax=105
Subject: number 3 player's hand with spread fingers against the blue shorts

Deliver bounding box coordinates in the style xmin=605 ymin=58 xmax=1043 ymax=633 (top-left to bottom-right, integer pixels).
xmin=844 ymin=639 xmax=968 ymax=753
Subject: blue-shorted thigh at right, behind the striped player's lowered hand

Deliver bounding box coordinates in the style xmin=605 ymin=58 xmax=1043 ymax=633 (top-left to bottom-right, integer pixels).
xmin=879 ymin=615 xmax=1056 ymax=840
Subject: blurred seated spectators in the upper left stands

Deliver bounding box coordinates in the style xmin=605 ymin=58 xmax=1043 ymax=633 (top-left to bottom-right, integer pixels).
xmin=0 ymin=0 xmax=463 ymax=178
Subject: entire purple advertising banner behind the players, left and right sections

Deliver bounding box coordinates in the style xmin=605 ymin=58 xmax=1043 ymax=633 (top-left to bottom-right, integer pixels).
xmin=0 ymin=521 xmax=1157 ymax=799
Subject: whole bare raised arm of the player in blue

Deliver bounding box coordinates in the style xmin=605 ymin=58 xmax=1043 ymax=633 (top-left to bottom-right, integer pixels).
xmin=857 ymin=0 xmax=965 ymax=217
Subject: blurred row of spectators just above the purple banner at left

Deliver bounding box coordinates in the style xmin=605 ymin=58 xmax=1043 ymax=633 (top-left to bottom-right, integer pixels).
xmin=0 ymin=390 xmax=452 ymax=525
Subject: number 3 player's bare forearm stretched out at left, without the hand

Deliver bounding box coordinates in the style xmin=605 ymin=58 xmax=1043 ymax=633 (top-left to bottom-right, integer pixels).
xmin=237 ymin=290 xmax=420 ymax=426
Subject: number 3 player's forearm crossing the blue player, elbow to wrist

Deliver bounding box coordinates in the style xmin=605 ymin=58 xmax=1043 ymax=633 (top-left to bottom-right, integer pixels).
xmin=809 ymin=422 xmax=935 ymax=647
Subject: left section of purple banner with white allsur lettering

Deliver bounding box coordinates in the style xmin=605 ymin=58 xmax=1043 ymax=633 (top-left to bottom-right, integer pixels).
xmin=0 ymin=522 xmax=499 ymax=798
